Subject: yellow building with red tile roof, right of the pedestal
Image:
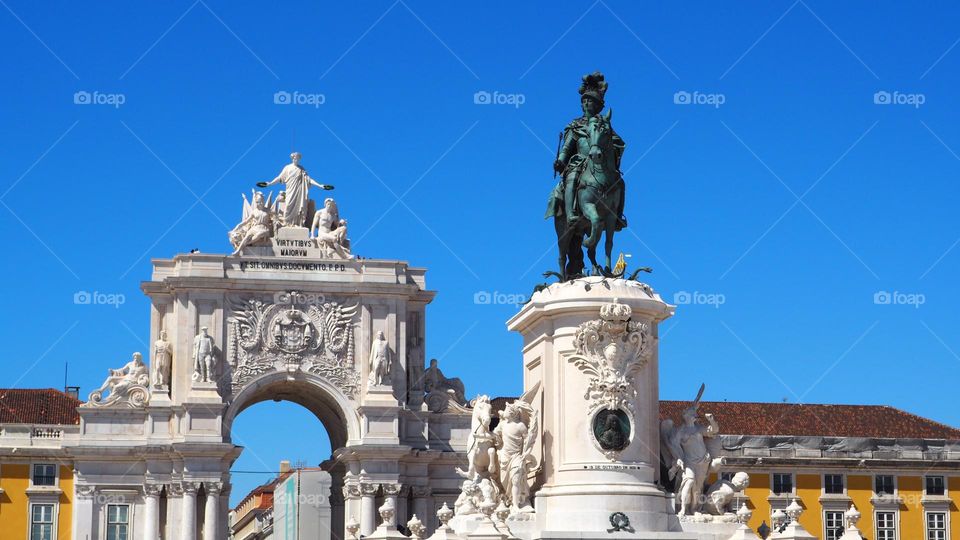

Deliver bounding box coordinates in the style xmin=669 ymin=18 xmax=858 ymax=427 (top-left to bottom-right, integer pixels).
xmin=676 ymin=402 xmax=960 ymax=540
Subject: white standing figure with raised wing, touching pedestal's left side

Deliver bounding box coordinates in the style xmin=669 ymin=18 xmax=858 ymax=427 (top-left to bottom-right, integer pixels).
xmin=493 ymin=400 xmax=538 ymax=513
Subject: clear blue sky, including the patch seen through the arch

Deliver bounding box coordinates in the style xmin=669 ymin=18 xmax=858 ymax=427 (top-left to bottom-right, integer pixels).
xmin=0 ymin=0 xmax=960 ymax=499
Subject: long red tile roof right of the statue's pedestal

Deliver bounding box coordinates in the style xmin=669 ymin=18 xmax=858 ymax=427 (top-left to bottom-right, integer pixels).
xmin=660 ymin=401 xmax=960 ymax=440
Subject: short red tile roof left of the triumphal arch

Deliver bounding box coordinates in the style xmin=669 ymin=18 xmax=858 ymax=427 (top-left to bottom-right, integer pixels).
xmin=0 ymin=388 xmax=82 ymax=424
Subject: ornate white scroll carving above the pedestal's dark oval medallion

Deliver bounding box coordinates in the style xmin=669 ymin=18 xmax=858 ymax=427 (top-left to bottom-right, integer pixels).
xmin=570 ymin=300 xmax=656 ymax=409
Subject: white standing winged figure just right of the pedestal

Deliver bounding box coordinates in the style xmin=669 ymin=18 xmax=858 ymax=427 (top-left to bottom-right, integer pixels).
xmin=660 ymin=385 xmax=724 ymax=517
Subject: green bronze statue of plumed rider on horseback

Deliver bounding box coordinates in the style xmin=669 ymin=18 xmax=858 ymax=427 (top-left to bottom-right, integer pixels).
xmin=546 ymin=72 xmax=627 ymax=280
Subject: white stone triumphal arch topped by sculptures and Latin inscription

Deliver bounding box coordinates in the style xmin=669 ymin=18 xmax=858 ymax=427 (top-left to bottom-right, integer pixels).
xmin=71 ymin=151 xmax=480 ymax=540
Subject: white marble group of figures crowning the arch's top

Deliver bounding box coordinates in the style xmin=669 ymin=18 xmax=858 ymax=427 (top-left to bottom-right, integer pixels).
xmin=228 ymin=152 xmax=353 ymax=259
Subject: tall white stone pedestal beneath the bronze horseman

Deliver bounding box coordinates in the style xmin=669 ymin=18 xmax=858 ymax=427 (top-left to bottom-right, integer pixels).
xmin=507 ymin=277 xmax=696 ymax=538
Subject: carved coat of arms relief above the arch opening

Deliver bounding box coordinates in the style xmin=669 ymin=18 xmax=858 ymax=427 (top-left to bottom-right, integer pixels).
xmin=228 ymin=291 xmax=360 ymax=397
